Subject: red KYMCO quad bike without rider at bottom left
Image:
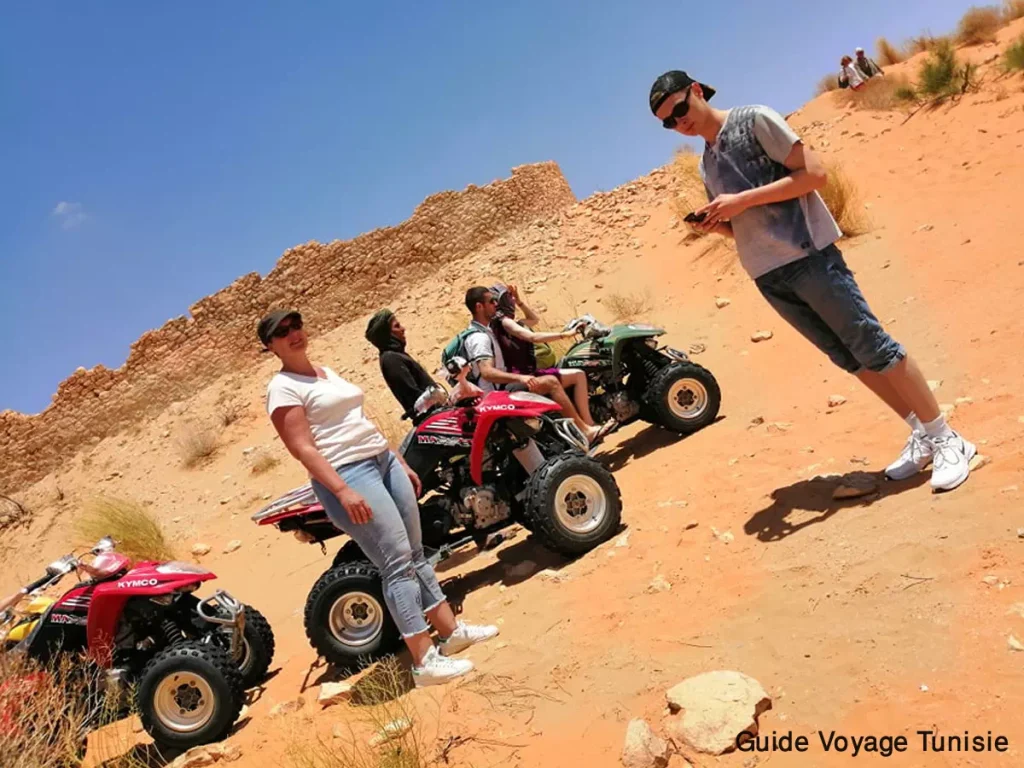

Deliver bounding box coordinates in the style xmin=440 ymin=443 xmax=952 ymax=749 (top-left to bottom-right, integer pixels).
xmin=0 ymin=538 xmax=274 ymax=750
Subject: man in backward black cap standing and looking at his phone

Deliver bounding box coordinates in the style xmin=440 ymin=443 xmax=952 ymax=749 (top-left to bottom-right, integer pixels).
xmin=649 ymin=71 xmax=976 ymax=490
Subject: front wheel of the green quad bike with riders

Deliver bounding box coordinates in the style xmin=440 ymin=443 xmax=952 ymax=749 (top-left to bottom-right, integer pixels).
xmin=644 ymin=362 xmax=722 ymax=434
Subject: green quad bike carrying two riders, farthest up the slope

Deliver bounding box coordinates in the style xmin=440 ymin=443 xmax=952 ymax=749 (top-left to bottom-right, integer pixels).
xmin=558 ymin=314 xmax=722 ymax=434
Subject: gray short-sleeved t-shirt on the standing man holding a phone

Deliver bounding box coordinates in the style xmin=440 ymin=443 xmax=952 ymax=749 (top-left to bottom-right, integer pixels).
xmin=700 ymin=105 xmax=843 ymax=279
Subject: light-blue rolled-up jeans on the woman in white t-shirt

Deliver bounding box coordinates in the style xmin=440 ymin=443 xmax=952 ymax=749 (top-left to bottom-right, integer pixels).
xmin=312 ymin=451 xmax=444 ymax=638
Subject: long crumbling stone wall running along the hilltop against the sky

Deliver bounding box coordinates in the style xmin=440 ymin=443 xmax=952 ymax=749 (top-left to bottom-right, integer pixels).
xmin=0 ymin=163 xmax=575 ymax=494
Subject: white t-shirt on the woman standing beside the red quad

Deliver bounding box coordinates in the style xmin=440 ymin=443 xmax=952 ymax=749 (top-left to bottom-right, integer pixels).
xmin=266 ymin=368 xmax=388 ymax=467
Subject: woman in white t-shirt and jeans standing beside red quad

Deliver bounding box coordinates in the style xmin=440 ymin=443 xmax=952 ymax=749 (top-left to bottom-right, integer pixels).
xmin=257 ymin=310 xmax=498 ymax=686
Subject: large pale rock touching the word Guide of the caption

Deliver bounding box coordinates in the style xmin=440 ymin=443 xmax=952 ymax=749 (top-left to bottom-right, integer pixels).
xmin=665 ymin=671 xmax=771 ymax=755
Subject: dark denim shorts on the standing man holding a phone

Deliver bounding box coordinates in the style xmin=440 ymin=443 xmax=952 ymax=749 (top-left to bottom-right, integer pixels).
xmin=755 ymin=246 xmax=906 ymax=374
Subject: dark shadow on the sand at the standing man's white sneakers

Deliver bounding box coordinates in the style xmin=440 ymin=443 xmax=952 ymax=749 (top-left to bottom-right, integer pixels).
xmin=743 ymin=472 xmax=928 ymax=543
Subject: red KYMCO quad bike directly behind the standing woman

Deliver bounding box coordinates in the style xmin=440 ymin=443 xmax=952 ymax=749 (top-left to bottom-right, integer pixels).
xmin=253 ymin=358 xmax=622 ymax=670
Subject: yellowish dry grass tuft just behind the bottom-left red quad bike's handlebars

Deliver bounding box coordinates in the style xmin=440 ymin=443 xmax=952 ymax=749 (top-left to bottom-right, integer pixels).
xmin=75 ymin=497 xmax=174 ymax=561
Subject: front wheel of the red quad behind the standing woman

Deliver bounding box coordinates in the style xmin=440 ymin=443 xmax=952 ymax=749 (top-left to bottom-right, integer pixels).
xmin=526 ymin=454 xmax=623 ymax=557
